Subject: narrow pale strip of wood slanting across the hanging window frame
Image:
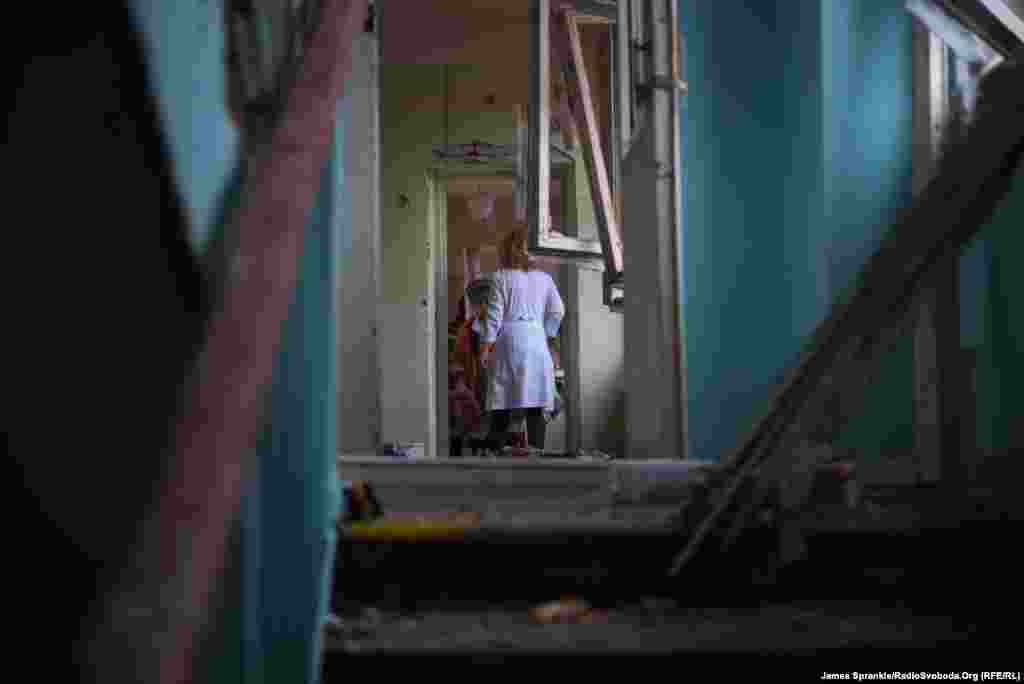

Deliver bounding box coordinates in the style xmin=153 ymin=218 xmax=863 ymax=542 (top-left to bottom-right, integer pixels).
xmin=550 ymin=8 xmax=623 ymax=274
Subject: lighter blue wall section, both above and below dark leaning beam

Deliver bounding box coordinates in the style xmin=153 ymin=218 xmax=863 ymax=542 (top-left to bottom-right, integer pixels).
xmin=820 ymin=0 xmax=913 ymax=460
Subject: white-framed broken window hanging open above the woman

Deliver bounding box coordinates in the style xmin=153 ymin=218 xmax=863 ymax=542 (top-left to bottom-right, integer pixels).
xmin=526 ymin=0 xmax=623 ymax=296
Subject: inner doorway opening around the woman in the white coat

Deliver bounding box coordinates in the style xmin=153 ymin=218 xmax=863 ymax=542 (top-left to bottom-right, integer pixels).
xmin=435 ymin=172 xmax=573 ymax=458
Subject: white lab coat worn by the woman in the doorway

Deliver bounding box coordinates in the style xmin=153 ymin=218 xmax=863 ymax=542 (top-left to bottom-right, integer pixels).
xmin=483 ymin=269 xmax=565 ymax=411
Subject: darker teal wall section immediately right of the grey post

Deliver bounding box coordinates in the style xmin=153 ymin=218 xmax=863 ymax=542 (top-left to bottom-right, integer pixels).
xmin=680 ymin=1 xmax=797 ymax=460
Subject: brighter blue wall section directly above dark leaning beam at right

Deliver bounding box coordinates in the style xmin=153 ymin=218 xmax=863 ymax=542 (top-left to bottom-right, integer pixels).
xmin=820 ymin=0 xmax=913 ymax=298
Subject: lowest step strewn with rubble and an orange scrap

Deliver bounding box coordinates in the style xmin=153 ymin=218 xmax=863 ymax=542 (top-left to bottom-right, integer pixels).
xmin=325 ymin=597 xmax=974 ymax=654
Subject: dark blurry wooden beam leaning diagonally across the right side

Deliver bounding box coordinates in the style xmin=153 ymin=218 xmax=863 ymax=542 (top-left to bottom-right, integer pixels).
xmin=671 ymin=60 xmax=1024 ymax=574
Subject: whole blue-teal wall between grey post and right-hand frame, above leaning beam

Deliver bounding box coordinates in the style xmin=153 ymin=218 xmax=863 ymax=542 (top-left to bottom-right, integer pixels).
xmin=680 ymin=0 xmax=912 ymax=460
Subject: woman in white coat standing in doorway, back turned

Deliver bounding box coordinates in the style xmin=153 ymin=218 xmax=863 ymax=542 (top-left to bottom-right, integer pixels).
xmin=481 ymin=229 xmax=565 ymax=450
